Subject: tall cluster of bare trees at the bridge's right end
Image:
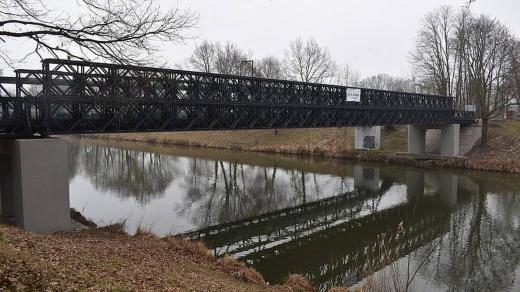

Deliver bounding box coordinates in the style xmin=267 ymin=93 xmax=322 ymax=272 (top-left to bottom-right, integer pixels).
xmin=412 ymin=7 xmax=519 ymax=146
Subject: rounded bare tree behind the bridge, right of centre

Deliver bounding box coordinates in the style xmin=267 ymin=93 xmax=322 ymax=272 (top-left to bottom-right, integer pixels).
xmin=284 ymin=38 xmax=336 ymax=82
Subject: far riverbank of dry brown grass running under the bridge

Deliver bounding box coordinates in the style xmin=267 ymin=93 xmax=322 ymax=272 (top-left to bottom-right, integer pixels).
xmin=88 ymin=121 xmax=520 ymax=173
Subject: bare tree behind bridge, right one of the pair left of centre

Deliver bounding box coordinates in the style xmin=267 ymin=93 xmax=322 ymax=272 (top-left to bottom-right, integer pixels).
xmin=215 ymin=42 xmax=249 ymax=75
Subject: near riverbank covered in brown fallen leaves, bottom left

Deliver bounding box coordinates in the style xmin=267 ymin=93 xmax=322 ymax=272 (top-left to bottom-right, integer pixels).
xmin=0 ymin=223 xmax=340 ymax=292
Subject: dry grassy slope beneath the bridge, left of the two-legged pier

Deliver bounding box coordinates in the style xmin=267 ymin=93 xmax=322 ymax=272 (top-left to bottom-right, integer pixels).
xmin=92 ymin=127 xmax=407 ymax=155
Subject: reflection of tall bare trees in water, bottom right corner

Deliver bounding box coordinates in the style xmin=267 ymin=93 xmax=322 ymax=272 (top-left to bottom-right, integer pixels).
xmin=417 ymin=177 xmax=520 ymax=291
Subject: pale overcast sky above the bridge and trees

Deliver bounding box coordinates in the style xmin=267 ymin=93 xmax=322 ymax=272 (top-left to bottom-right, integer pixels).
xmin=1 ymin=0 xmax=520 ymax=77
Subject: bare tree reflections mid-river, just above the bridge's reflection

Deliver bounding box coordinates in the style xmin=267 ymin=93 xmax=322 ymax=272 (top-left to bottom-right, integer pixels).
xmin=175 ymin=158 xmax=358 ymax=228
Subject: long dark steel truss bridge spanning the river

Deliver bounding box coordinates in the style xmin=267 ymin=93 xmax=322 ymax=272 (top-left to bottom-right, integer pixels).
xmin=0 ymin=59 xmax=475 ymax=137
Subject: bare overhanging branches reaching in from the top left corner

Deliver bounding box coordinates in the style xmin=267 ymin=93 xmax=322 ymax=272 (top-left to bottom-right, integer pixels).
xmin=0 ymin=0 xmax=198 ymax=66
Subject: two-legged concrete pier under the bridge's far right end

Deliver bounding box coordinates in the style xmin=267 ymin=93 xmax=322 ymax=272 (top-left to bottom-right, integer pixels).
xmin=408 ymin=124 xmax=460 ymax=156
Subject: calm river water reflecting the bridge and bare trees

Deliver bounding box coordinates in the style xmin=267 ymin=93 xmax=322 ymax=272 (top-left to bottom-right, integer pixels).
xmin=70 ymin=140 xmax=520 ymax=291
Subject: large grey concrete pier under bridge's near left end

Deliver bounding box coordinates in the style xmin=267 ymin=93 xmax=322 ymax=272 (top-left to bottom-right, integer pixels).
xmin=0 ymin=138 xmax=71 ymax=233
